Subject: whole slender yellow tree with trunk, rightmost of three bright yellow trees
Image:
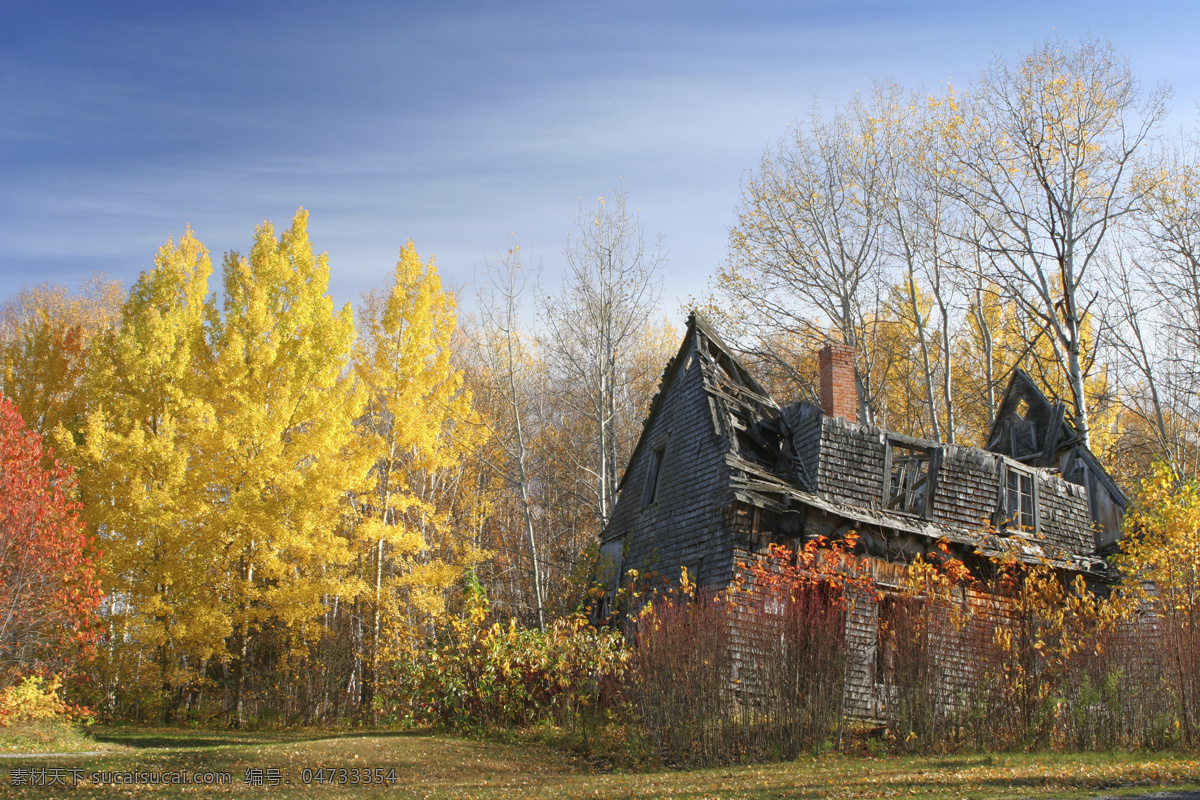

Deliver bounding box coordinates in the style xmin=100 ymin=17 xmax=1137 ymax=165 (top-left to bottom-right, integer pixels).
xmin=355 ymin=241 xmax=481 ymax=715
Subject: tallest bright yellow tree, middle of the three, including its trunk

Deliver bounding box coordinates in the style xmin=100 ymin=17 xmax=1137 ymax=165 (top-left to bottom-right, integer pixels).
xmin=202 ymin=209 xmax=368 ymax=724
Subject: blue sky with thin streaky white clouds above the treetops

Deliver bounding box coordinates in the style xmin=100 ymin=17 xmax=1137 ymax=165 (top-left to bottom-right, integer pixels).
xmin=0 ymin=0 xmax=1200 ymax=315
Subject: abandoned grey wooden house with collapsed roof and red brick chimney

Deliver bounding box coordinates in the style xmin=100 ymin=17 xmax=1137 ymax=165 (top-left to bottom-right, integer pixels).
xmin=599 ymin=313 xmax=1128 ymax=717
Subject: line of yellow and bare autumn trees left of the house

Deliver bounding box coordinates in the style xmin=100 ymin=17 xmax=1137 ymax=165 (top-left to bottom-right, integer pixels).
xmin=0 ymin=192 xmax=674 ymax=724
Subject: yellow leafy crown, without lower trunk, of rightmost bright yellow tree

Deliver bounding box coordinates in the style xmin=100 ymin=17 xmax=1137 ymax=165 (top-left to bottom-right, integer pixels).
xmin=355 ymin=242 xmax=480 ymax=614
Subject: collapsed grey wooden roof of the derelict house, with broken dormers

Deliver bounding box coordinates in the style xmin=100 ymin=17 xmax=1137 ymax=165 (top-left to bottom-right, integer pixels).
xmin=622 ymin=312 xmax=1128 ymax=577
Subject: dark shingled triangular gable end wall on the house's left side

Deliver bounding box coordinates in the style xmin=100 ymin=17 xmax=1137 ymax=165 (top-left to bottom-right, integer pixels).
xmin=605 ymin=337 xmax=733 ymax=592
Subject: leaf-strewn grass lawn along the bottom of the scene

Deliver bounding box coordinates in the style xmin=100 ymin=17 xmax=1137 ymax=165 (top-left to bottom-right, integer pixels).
xmin=0 ymin=728 xmax=1200 ymax=800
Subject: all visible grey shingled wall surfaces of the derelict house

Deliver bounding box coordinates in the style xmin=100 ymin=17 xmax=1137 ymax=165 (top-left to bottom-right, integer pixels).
xmin=604 ymin=316 xmax=1108 ymax=718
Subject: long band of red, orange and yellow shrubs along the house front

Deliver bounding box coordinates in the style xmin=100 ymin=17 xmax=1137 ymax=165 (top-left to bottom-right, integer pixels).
xmin=369 ymin=510 xmax=1196 ymax=765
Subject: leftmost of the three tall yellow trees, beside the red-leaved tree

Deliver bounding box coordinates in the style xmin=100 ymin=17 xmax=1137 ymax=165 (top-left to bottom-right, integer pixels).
xmin=58 ymin=229 xmax=218 ymax=720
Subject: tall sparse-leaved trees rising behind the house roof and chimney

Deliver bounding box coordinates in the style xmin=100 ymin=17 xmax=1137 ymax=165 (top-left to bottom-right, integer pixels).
xmin=710 ymin=40 xmax=1166 ymax=465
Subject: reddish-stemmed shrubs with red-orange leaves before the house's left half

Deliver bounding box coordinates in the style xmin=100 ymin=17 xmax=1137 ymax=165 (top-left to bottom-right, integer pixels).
xmin=626 ymin=542 xmax=874 ymax=764
